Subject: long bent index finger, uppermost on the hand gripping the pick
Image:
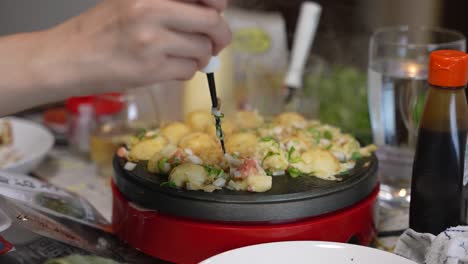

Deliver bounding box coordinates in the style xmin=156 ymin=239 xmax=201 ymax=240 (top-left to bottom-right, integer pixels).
xmin=162 ymin=2 xmax=231 ymax=54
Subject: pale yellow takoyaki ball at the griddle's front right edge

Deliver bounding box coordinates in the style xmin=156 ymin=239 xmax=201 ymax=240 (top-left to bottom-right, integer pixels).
xmin=291 ymin=148 xmax=340 ymax=180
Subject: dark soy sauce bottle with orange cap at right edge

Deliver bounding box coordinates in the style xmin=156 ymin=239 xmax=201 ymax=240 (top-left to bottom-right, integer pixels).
xmin=410 ymin=50 xmax=468 ymax=235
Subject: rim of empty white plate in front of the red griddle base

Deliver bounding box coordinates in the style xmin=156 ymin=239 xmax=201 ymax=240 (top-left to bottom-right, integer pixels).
xmin=201 ymin=241 xmax=415 ymax=264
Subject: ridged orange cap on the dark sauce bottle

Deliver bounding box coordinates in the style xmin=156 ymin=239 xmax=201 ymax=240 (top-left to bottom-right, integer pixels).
xmin=429 ymin=50 xmax=468 ymax=87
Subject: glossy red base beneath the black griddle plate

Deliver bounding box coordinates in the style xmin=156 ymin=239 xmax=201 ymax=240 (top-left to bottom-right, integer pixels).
xmin=112 ymin=182 xmax=379 ymax=263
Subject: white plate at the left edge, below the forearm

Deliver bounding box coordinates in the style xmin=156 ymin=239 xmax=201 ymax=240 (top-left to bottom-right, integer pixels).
xmin=0 ymin=117 xmax=54 ymax=174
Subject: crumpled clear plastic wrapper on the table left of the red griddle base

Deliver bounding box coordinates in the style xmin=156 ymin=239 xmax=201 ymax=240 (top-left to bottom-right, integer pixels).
xmin=0 ymin=172 xmax=159 ymax=264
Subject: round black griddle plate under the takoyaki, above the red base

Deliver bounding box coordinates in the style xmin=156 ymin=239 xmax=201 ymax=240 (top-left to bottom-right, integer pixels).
xmin=113 ymin=155 xmax=377 ymax=223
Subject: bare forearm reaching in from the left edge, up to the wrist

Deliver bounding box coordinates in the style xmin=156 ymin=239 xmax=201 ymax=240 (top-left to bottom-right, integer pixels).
xmin=0 ymin=28 xmax=87 ymax=116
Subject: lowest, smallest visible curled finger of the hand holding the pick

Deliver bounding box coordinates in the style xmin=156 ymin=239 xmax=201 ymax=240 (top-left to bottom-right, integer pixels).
xmin=159 ymin=56 xmax=198 ymax=81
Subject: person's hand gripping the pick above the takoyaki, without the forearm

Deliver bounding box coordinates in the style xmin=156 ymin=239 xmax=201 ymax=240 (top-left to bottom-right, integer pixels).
xmin=44 ymin=0 xmax=231 ymax=90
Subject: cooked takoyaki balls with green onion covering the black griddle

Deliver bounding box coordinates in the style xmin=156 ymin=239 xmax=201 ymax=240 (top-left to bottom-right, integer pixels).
xmin=118 ymin=111 xmax=376 ymax=192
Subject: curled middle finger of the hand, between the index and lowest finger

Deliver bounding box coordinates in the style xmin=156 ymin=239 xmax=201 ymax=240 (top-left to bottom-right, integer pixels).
xmin=165 ymin=32 xmax=213 ymax=69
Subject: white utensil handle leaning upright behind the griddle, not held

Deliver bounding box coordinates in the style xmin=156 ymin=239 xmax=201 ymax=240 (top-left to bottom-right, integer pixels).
xmin=285 ymin=1 xmax=322 ymax=88
